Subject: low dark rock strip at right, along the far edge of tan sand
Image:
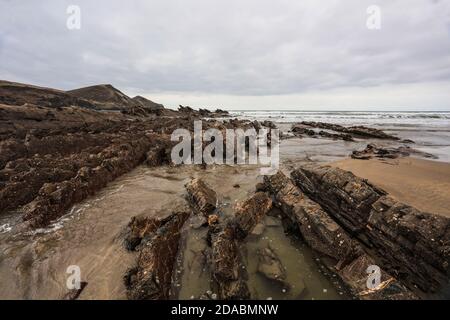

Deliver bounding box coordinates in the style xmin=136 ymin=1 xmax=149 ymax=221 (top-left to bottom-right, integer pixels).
xmin=351 ymin=143 xmax=436 ymax=160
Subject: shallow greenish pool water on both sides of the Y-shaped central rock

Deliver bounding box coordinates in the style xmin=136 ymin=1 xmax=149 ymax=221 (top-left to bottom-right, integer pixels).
xmin=172 ymin=208 xmax=347 ymax=300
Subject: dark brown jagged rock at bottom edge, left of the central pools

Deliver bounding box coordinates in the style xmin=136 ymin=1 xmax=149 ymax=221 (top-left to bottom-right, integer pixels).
xmin=124 ymin=211 xmax=189 ymax=300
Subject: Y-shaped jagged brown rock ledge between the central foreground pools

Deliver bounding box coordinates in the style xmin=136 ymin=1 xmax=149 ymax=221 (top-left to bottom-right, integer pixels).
xmin=186 ymin=179 xmax=272 ymax=300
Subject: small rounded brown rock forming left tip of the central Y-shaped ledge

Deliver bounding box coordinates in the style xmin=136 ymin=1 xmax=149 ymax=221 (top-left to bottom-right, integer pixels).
xmin=186 ymin=179 xmax=217 ymax=218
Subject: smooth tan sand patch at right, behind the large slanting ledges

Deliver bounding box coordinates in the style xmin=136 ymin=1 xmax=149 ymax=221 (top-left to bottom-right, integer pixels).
xmin=331 ymin=157 xmax=450 ymax=217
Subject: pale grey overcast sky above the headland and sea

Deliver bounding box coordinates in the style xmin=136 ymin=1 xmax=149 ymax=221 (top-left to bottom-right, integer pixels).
xmin=0 ymin=0 xmax=450 ymax=110
